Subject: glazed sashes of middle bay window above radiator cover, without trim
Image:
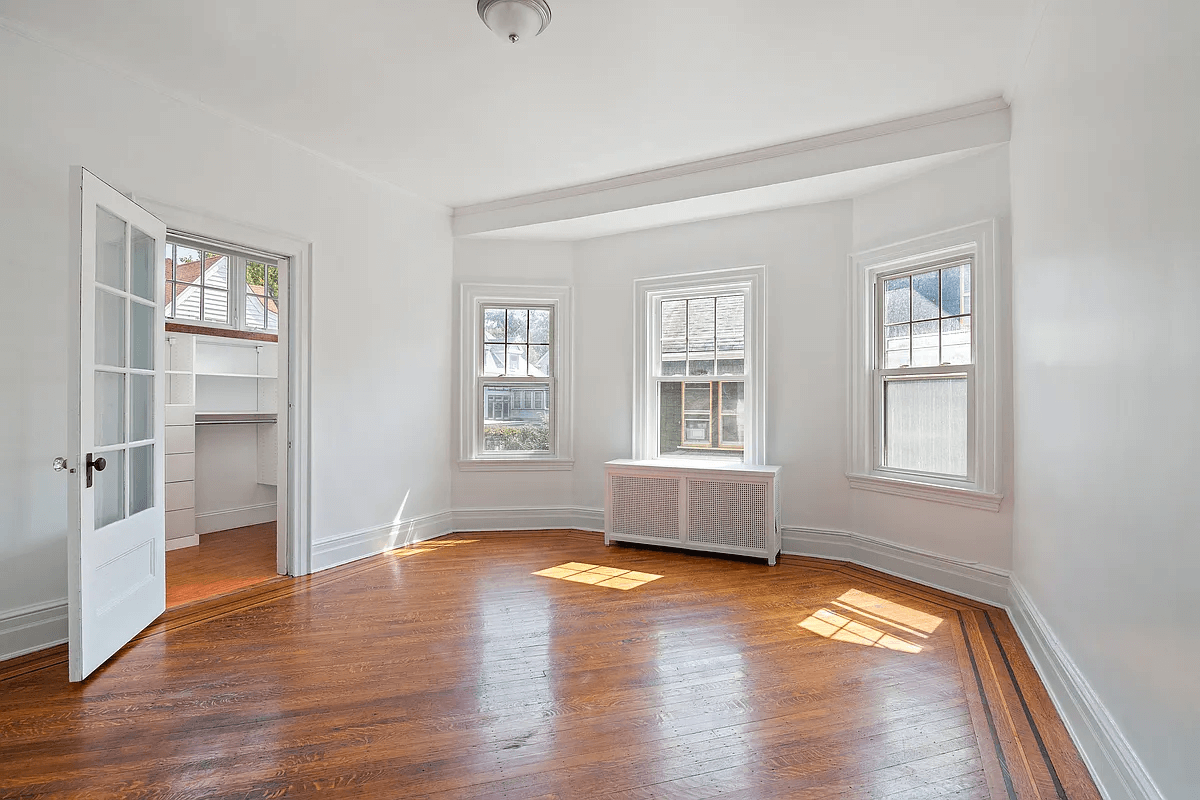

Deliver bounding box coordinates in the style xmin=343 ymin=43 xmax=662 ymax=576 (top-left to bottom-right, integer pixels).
xmin=654 ymin=291 xmax=746 ymax=461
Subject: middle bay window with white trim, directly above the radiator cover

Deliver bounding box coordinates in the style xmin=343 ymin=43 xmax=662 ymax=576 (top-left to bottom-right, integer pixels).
xmin=634 ymin=267 xmax=766 ymax=464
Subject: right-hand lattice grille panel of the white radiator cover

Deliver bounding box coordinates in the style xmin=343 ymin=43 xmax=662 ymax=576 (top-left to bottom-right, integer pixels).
xmin=688 ymin=479 xmax=768 ymax=551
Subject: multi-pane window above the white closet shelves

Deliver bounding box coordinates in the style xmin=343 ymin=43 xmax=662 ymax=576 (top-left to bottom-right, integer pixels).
xmin=163 ymin=236 xmax=280 ymax=333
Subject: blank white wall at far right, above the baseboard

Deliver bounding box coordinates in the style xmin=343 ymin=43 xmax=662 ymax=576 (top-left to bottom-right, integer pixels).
xmin=1010 ymin=0 xmax=1200 ymax=800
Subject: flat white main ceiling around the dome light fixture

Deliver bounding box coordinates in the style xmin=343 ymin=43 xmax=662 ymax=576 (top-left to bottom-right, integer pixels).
xmin=0 ymin=0 xmax=1034 ymax=206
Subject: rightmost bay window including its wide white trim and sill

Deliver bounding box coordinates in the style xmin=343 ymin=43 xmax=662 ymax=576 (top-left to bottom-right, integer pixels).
xmin=850 ymin=223 xmax=1002 ymax=510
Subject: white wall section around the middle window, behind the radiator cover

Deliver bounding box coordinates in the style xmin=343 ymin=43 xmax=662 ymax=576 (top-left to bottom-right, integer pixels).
xmin=574 ymin=201 xmax=851 ymax=530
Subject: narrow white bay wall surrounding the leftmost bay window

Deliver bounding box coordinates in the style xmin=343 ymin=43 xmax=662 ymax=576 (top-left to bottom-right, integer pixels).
xmin=451 ymin=239 xmax=581 ymax=513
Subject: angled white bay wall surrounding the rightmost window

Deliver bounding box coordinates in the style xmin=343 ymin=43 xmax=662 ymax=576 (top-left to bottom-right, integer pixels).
xmin=847 ymin=145 xmax=1014 ymax=570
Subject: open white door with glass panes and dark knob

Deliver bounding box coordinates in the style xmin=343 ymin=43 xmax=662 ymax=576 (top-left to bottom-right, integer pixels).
xmin=67 ymin=167 xmax=167 ymax=680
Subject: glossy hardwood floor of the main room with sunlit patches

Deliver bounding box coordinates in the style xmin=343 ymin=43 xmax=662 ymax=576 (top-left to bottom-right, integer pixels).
xmin=0 ymin=531 xmax=1099 ymax=800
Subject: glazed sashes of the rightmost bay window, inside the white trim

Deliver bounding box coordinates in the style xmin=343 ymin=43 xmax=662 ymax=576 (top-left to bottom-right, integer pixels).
xmin=875 ymin=259 xmax=974 ymax=481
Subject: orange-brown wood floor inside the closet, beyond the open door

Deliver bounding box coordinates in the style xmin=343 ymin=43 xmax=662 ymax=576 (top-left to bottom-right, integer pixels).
xmin=167 ymin=522 xmax=280 ymax=608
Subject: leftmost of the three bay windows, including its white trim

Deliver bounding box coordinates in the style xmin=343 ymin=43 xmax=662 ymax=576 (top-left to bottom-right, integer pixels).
xmin=460 ymin=284 xmax=571 ymax=469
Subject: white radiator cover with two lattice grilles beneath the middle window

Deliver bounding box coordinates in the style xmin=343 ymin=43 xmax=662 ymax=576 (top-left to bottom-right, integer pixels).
xmin=604 ymin=459 xmax=780 ymax=565
